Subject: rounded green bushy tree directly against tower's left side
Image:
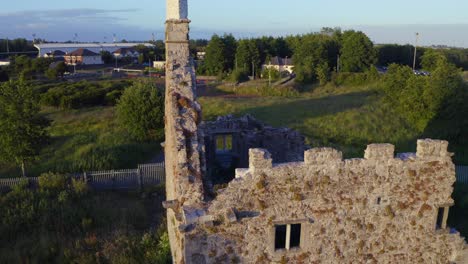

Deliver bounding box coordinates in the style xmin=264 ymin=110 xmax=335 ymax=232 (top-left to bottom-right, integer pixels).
xmin=117 ymin=81 xmax=164 ymax=141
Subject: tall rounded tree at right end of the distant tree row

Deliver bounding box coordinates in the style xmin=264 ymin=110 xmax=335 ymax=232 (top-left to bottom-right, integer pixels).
xmin=340 ymin=30 xmax=377 ymax=72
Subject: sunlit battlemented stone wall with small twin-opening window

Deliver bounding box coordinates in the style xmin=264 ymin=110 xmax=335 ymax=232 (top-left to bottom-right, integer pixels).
xmin=177 ymin=140 xmax=465 ymax=263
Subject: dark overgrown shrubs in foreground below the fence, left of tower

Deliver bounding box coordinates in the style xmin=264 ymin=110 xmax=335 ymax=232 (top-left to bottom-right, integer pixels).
xmin=0 ymin=173 xmax=171 ymax=264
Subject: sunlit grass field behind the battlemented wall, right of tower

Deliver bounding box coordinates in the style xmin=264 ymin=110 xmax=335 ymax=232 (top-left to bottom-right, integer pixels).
xmin=200 ymin=81 xmax=458 ymax=158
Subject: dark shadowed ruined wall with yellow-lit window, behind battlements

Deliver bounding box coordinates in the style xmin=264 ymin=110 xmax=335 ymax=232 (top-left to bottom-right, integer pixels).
xmin=200 ymin=115 xmax=307 ymax=187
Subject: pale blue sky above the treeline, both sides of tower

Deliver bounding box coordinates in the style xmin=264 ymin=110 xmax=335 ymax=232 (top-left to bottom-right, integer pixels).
xmin=0 ymin=0 xmax=468 ymax=47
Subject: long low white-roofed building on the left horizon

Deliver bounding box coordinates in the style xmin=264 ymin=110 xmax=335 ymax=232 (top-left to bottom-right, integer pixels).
xmin=34 ymin=43 xmax=154 ymax=57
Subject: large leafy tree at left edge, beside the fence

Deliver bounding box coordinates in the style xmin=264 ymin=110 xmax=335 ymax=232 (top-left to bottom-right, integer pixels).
xmin=0 ymin=80 xmax=50 ymax=176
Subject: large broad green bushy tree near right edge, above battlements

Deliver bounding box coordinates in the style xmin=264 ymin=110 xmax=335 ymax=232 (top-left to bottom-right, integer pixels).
xmin=384 ymin=59 xmax=466 ymax=133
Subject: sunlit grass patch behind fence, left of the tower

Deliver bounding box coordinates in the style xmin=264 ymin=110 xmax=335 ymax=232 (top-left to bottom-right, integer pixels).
xmin=0 ymin=107 xmax=160 ymax=177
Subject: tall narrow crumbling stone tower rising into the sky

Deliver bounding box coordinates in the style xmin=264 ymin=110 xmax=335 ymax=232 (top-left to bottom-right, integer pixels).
xmin=164 ymin=0 xmax=203 ymax=263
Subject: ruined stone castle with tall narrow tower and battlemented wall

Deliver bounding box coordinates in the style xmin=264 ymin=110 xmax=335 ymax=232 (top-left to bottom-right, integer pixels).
xmin=164 ymin=0 xmax=467 ymax=264
